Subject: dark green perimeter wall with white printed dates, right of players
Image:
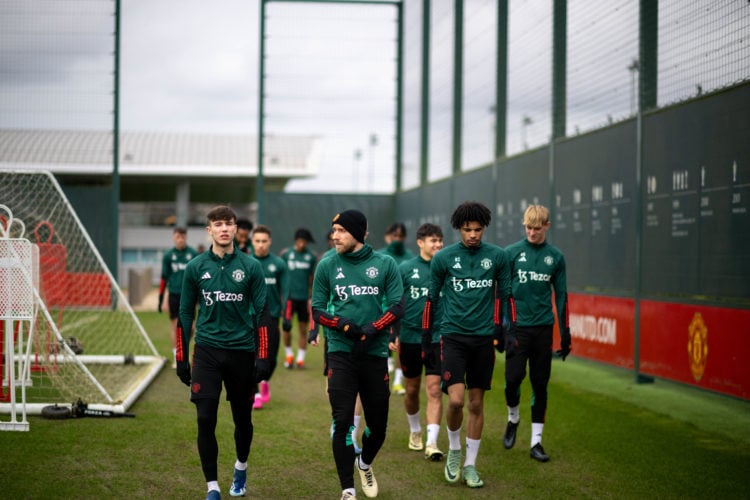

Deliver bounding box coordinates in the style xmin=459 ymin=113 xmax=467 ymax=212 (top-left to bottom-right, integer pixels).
xmin=395 ymin=84 xmax=750 ymax=308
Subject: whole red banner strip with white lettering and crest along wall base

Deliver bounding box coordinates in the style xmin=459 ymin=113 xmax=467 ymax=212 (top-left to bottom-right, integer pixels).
xmin=569 ymin=293 xmax=750 ymax=399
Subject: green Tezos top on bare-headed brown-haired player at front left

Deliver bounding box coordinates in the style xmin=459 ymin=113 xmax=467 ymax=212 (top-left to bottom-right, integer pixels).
xmin=180 ymin=248 xmax=266 ymax=351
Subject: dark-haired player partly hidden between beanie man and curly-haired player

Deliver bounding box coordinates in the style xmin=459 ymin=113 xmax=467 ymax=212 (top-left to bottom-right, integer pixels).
xmin=390 ymin=222 xmax=443 ymax=462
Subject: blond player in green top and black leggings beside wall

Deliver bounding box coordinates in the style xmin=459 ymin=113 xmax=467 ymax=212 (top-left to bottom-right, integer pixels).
xmin=503 ymin=205 xmax=570 ymax=462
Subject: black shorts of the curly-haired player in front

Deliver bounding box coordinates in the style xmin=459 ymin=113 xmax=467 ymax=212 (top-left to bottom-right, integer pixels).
xmin=441 ymin=334 xmax=495 ymax=391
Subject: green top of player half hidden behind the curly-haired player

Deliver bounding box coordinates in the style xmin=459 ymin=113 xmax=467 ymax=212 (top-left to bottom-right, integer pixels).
xmin=398 ymin=255 xmax=441 ymax=344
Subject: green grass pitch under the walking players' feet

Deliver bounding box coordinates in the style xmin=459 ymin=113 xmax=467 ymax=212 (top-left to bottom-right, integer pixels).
xmin=0 ymin=312 xmax=750 ymax=499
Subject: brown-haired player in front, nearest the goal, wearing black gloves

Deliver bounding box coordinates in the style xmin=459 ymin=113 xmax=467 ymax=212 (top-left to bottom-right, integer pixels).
xmin=177 ymin=206 xmax=270 ymax=500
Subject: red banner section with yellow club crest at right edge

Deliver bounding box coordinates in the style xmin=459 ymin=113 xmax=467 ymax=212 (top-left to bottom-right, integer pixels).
xmin=640 ymin=301 xmax=750 ymax=399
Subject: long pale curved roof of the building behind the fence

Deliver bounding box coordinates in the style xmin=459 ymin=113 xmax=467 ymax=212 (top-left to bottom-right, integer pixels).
xmin=0 ymin=129 xmax=320 ymax=178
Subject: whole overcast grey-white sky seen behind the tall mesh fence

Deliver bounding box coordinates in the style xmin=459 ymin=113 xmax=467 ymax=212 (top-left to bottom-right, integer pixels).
xmin=0 ymin=0 xmax=750 ymax=192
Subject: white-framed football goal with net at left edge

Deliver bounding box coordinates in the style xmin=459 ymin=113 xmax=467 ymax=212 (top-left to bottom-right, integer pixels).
xmin=0 ymin=169 xmax=164 ymax=414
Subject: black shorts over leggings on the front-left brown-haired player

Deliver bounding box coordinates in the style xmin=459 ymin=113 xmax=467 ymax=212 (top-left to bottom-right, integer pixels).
xmin=190 ymin=344 xmax=255 ymax=401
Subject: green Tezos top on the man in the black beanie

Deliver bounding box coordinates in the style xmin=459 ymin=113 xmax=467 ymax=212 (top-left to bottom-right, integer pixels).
xmin=312 ymin=244 xmax=404 ymax=358
